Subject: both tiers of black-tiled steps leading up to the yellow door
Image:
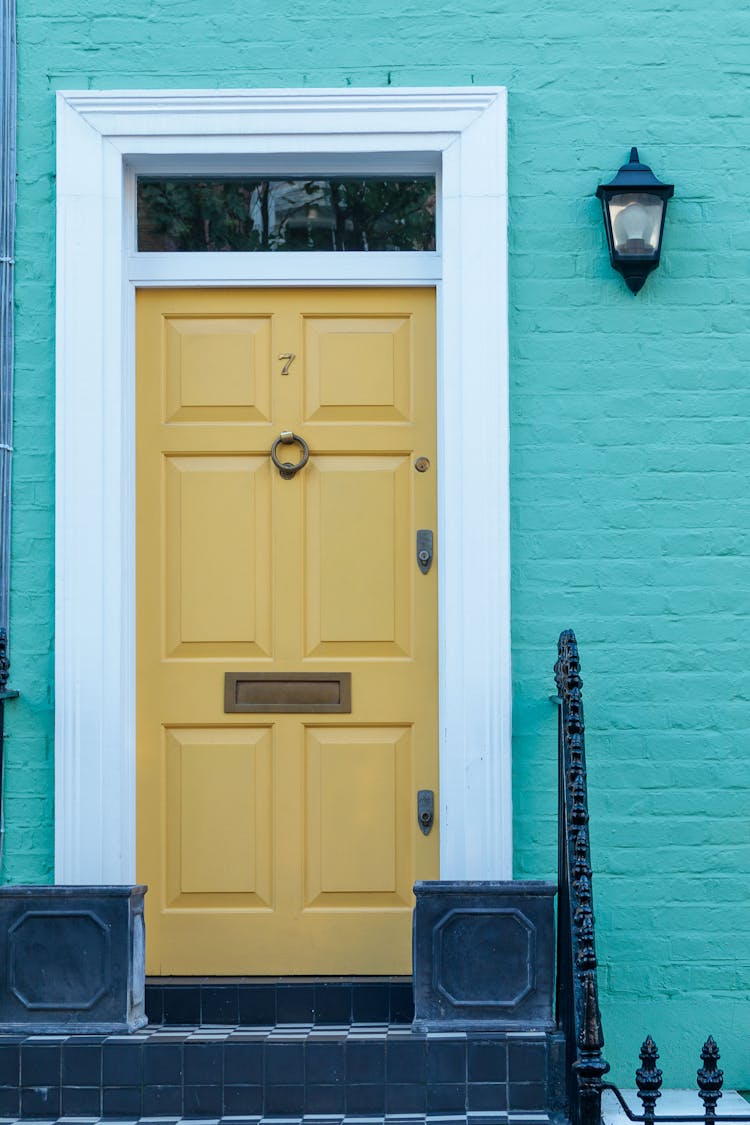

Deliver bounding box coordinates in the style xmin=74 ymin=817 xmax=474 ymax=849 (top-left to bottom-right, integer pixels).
xmin=0 ymin=978 xmax=554 ymax=1125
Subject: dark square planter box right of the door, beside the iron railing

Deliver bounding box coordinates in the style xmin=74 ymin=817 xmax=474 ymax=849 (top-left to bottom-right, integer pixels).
xmin=414 ymin=881 xmax=555 ymax=1031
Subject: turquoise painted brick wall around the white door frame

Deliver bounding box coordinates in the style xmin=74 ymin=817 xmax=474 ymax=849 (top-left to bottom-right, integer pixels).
xmin=2 ymin=0 xmax=750 ymax=1086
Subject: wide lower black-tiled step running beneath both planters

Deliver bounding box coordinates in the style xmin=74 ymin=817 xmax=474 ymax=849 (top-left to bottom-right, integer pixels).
xmin=0 ymin=1023 xmax=553 ymax=1125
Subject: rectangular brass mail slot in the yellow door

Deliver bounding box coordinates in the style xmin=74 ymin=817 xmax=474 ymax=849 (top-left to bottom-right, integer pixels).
xmin=224 ymin=672 xmax=352 ymax=714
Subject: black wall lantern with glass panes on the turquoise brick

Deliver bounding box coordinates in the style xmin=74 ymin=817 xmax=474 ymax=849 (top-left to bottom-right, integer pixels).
xmin=596 ymin=149 xmax=675 ymax=293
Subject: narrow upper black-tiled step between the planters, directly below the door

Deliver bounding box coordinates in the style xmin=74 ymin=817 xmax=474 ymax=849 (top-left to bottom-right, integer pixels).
xmin=146 ymin=977 xmax=414 ymax=1027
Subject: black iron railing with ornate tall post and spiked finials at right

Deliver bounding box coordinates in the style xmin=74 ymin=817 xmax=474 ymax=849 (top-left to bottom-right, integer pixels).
xmin=554 ymin=629 xmax=750 ymax=1125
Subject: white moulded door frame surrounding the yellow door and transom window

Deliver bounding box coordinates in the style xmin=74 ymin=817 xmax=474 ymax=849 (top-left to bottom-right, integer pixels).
xmin=55 ymin=88 xmax=512 ymax=883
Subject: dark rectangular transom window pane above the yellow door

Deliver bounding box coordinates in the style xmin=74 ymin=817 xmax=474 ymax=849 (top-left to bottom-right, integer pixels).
xmin=138 ymin=177 xmax=435 ymax=251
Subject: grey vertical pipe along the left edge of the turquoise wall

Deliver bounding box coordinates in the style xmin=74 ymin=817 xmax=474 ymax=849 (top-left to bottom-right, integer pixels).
xmin=0 ymin=0 xmax=18 ymax=869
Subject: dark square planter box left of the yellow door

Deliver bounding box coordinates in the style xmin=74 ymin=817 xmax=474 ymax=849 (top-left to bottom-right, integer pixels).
xmin=0 ymin=887 xmax=146 ymax=1034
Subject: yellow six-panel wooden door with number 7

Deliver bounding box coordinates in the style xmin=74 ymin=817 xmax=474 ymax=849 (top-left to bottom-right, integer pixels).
xmin=136 ymin=289 xmax=439 ymax=974
